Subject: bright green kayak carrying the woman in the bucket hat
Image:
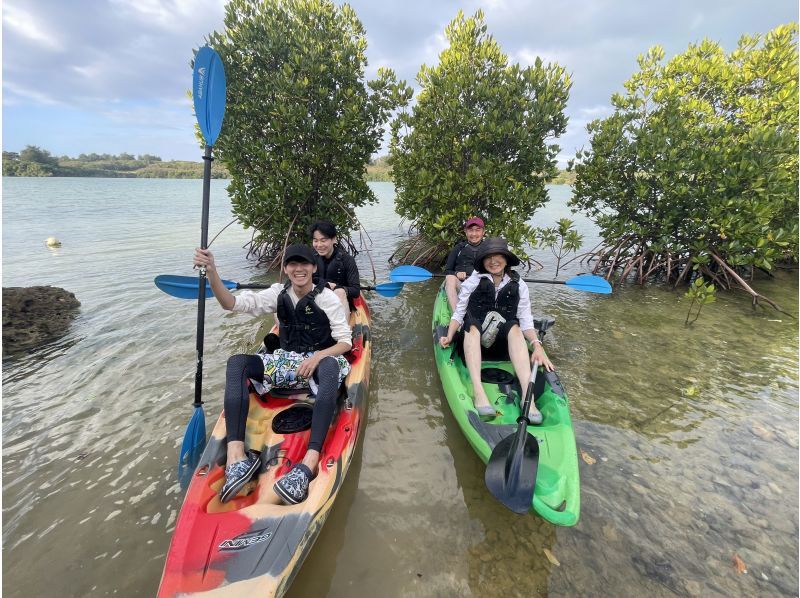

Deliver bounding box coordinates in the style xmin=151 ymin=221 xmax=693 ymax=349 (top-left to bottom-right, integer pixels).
xmin=433 ymin=286 xmax=581 ymax=525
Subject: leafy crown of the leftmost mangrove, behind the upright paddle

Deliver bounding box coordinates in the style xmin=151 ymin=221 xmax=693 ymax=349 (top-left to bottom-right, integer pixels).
xmin=209 ymin=0 xmax=410 ymax=259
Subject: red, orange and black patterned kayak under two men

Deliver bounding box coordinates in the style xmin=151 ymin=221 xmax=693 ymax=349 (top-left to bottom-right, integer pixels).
xmin=158 ymin=298 xmax=371 ymax=596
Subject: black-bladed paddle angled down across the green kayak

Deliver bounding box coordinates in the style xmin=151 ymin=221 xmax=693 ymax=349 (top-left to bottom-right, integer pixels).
xmin=484 ymin=364 xmax=539 ymax=514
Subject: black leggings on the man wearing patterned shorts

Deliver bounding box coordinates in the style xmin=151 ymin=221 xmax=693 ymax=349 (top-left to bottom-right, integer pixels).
xmin=225 ymin=355 xmax=339 ymax=451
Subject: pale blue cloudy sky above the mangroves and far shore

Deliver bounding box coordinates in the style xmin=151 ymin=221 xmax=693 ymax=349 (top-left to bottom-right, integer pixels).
xmin=2 ymin=0 xmax=798 ymax=166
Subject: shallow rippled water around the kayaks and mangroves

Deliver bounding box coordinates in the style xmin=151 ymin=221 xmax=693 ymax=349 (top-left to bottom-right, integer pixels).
xmin=3 ymin=179 xmax=798 ymax=597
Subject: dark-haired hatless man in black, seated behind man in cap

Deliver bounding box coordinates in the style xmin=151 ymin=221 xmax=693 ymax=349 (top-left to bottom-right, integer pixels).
xmin=309 ymin=220 xmax=361 ymax=313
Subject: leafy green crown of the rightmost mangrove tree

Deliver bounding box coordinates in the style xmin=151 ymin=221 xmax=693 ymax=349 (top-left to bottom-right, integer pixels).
xmin=572 ymin=23 xmax=798 ymax=298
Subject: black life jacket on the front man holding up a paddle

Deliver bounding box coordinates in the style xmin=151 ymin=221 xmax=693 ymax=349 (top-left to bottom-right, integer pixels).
xmin=278 ymin=282 xmax=336 ymax=353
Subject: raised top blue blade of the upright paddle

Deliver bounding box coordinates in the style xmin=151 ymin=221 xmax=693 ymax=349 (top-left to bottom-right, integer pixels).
xmin=192 ymin=46 xmax=225 ymax=146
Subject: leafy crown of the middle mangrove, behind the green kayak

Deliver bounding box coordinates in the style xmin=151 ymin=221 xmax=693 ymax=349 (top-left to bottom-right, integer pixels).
xmin=390 ymin=11 xmax=571 ymax=262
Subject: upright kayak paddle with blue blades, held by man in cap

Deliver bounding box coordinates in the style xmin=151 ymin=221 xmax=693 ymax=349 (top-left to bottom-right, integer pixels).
xmin=178 ymin=46 xmax=225 ymax=470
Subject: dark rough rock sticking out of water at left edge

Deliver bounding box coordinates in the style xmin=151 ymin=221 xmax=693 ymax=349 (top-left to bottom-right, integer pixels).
xmin=3 ymin=286 xmax=81 ymax=356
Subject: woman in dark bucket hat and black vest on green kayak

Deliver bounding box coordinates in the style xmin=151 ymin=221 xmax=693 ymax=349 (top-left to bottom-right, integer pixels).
xmin=439 ymin=237 xmax=553 ymax=424
